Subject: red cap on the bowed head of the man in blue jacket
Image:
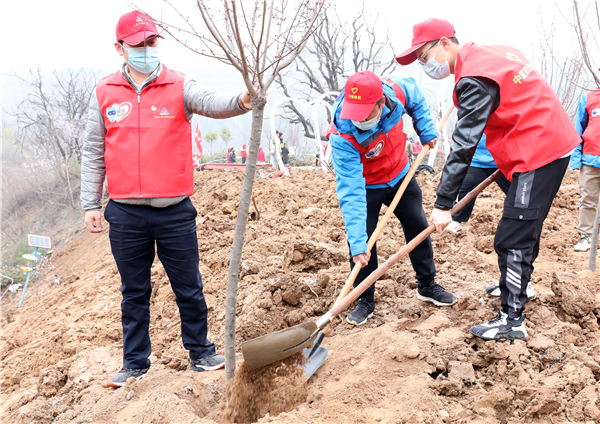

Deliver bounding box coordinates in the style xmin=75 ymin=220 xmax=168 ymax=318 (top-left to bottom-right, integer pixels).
xmin=340 ymin=71 xmax=383 ymax=121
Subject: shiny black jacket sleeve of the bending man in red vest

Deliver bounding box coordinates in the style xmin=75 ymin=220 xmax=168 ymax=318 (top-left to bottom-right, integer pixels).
xmin=435 ymin=77 xmax=500 ymax=209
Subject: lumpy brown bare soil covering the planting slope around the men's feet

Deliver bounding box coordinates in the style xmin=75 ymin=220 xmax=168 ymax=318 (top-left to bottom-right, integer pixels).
xmin=0 ymin=169 xmax=600 ymax=423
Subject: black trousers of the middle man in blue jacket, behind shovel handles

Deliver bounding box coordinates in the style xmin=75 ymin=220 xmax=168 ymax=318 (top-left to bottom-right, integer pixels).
xmin=350 ymin=177 xmax=435 ymax=304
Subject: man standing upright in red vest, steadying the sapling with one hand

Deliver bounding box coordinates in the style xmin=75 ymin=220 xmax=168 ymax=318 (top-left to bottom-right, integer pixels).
xmin=81 ymin=11 xmax=251 ymax=387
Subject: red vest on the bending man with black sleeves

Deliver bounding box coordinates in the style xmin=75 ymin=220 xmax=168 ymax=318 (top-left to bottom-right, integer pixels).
xmin=454 ymin=43 xmax=580 ymax=181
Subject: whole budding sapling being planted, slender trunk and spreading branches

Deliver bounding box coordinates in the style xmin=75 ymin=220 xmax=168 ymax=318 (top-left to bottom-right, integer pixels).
xmin=152 ymin=0 xmax=323 ymax=381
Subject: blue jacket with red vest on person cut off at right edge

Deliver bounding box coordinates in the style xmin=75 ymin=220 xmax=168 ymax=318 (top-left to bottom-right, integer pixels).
xmin=569 ymin=90 xmax=600 ymax=169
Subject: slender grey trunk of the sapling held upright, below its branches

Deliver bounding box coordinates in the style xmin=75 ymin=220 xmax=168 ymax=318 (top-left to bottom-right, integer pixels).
xmin=225 ymin=95 xmax=267 ymax=382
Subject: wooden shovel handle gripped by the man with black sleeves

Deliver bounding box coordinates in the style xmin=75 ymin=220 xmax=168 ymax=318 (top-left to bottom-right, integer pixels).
xmin=317 ymin=170 xmax=501 ymax=328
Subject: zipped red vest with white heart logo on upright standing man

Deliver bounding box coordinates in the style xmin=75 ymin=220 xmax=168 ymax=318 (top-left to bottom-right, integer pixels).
xmin=96 ymin=65 xmax=194 ymax=199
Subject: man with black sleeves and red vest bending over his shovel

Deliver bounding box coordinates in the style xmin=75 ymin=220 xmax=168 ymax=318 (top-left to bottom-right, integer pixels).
xmin=396 ymin=19 xmax=579 ymax=340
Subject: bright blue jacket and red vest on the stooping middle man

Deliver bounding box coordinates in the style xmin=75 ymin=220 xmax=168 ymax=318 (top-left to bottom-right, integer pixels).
xmin=329 ymin=75 xmax=439 ymax=256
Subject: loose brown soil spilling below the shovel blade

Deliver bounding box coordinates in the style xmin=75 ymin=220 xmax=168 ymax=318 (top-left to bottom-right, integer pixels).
xmin=221 ymin=352 xmax=308 ymax=423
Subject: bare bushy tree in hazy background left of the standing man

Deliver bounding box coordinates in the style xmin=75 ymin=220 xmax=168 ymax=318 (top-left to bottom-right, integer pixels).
xmin=8 ymin=68 xmax=98 ymax=208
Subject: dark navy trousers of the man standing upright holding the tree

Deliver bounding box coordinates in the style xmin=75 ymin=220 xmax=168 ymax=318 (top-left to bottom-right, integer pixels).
xmin=104 ymin=199 xmax=215 ymax=369
